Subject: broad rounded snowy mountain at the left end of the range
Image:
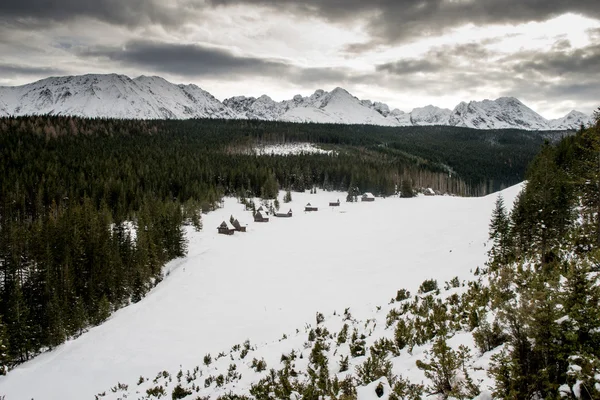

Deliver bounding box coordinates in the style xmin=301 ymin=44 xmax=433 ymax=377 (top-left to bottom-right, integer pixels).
xmin=0 ymin=74 xmax=237 ymax=119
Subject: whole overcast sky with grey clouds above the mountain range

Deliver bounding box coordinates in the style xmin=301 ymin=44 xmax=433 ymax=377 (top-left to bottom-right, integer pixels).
xmin=0 ymin=0 xmax=600 ymax=118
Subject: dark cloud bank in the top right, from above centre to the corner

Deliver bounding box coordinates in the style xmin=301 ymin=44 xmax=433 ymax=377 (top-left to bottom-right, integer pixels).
xmin=208 ymin=0 xmax=600 ymax=45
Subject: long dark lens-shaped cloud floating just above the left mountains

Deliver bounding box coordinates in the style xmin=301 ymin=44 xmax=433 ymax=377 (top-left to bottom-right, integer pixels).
xmin=79 ymin=41 xmax=349 ymax=83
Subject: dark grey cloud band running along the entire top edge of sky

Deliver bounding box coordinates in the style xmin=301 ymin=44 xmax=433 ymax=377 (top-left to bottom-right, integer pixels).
xmin=0 ymin=0 xmax=600 ymax=45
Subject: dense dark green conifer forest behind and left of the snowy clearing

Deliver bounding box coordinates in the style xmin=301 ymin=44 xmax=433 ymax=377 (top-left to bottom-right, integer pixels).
xmin=0 ymin=116 xmax=572 ymax=371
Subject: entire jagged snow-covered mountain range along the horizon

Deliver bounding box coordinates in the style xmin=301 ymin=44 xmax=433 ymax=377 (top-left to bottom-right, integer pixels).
xmin=0 ymin=74 xmax=591 ymax=130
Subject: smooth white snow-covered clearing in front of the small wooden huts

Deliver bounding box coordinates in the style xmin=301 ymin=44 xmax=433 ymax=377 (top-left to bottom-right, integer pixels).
xmin=0 ymin=186 xmax=520 ymax=400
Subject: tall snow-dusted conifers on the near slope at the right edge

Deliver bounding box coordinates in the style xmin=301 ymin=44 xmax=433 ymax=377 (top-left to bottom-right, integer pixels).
xmin=486 ymin=109 xmax=600 ymax=399
